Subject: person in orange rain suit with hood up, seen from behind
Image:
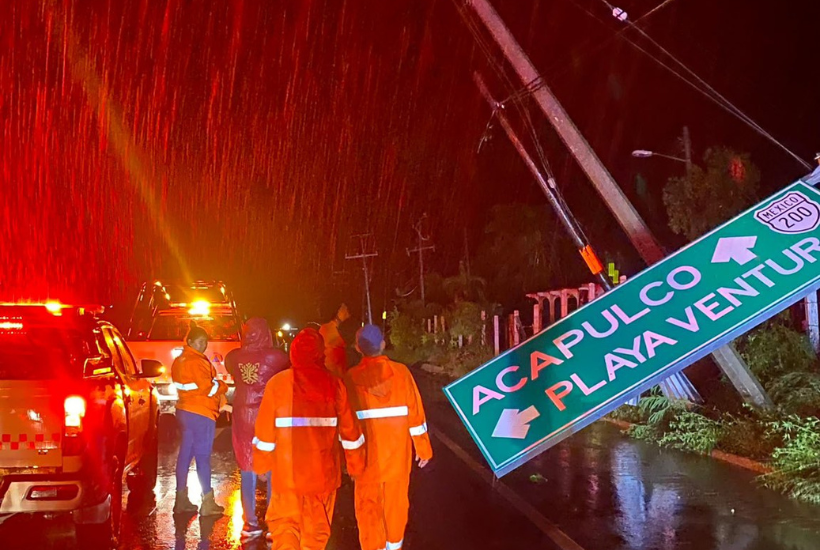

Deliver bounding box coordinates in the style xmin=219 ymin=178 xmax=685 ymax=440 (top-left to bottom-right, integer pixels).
xmin=253 ymin=328 xmax=365 ymax=550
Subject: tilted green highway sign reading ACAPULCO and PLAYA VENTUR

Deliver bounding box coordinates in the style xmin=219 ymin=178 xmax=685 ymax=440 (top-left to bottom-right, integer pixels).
xmin=444 ymin=182 xmax=820 ymax=476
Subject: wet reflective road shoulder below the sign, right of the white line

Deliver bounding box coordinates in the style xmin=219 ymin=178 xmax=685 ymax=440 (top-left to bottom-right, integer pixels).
xmin=505 ymin=423 xmax=820 ymax=550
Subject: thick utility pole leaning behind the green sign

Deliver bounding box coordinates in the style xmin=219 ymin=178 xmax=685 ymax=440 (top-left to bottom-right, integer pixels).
xmin=466 ymin=0 xmax=772 ymax=407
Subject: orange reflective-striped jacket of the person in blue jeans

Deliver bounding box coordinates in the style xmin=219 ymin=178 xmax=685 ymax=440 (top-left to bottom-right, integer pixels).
xmin=171 ymin=344 xmax=228 ymax=420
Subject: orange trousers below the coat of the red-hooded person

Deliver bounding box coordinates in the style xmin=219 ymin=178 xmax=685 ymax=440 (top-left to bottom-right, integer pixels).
xmin=265 ymin=491 xmax=336 ymax=550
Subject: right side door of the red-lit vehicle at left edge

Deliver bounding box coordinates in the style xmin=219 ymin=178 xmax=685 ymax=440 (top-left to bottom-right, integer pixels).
xmin=103 ymin=327 xmax=151 ymax=466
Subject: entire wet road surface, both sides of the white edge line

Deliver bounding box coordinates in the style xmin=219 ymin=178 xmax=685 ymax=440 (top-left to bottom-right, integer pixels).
xmin=0 ymin=373 xmax=820 ymax=550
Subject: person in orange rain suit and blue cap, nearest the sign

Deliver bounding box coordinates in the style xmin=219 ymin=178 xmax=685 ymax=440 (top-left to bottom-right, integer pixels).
xmin=345 ymin=325 xmax=433 ymax=550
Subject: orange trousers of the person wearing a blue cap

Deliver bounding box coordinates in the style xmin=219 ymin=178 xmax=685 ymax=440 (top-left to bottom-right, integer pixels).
xmin=354 ymin=476 xmax=410 ymax=550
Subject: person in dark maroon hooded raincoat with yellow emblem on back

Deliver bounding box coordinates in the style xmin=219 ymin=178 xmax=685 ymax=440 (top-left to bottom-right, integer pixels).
xmin=225 ymin=317 xmax=288 ymax=538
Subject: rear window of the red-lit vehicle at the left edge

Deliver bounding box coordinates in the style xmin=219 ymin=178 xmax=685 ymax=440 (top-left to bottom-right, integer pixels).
xmin=0 ymin=327 xmax=99 ymax=380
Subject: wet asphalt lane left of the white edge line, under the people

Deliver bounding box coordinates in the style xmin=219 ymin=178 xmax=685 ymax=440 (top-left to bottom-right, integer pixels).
xmin=0 ymin=414 xmax=556 ymax=550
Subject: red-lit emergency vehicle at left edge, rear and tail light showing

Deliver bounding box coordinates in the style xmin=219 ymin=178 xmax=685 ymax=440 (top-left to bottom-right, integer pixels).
xmin=0 ymin=302 xmax=162 ymax=548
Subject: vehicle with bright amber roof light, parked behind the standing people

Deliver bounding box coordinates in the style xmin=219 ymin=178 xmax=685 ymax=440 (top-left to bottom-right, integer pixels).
xmin=126 ymin=281 xmax=243 ymax=413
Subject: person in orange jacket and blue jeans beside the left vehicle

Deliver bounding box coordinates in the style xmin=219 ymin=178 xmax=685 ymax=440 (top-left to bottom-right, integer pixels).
xmin=171 ymin=321 xmax=228 ymax=516
